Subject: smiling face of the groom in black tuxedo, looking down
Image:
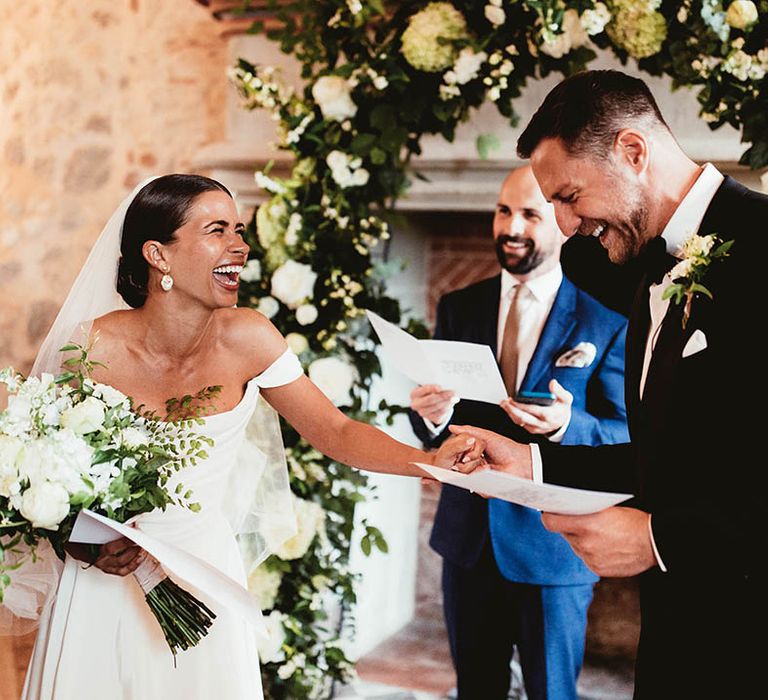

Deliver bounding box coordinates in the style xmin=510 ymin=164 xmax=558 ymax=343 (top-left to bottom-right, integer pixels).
xmin=531 ymin=138 xmax=652 ymax=264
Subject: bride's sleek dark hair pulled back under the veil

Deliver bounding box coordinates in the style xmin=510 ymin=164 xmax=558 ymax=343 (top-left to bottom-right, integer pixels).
xmin=117 ymin=175 xmax=232 ymax=309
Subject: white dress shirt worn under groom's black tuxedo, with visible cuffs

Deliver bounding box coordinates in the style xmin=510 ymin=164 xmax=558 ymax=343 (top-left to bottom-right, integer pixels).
xmin=531 ymin=163 xmax=725 ymax=572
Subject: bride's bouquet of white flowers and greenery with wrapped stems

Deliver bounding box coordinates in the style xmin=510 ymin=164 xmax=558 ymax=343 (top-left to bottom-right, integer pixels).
xmin=0 ymin=344 xmax=218 ymax=655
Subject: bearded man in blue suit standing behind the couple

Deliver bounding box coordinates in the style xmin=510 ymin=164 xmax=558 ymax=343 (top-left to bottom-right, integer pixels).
xmin=410 ymin=167 xmax=628 ymax=700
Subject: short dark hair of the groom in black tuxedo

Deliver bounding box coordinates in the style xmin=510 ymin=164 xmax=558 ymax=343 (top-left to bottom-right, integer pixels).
xmin=517 ymin=70 xmax=669 ymax=159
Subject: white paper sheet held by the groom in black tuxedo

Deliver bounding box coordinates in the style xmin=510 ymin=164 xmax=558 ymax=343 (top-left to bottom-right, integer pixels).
xmin=414 ymin=462 xmax=632 ymax=515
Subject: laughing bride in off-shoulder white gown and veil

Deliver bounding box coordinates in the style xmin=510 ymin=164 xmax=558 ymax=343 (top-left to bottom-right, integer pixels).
xmin=18 ymin=175 xmax=482 ymax=700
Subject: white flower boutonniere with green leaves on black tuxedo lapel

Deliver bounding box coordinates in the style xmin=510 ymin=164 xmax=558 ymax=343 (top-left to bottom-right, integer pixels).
xmin=661 ymin=232 xmax=733 ymax=328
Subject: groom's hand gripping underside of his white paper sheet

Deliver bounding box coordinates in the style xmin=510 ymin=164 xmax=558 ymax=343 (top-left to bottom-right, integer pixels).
xmin=541 ymin=506 xmax=656 ymax=576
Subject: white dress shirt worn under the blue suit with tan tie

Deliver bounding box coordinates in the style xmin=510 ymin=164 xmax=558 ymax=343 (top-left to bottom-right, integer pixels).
xmin=423 ymin=263 xmax=568 ymax=442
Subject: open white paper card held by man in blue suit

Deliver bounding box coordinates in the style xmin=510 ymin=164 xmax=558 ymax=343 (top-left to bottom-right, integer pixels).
xmin=366 ymin=311 xmax=509 ymax=404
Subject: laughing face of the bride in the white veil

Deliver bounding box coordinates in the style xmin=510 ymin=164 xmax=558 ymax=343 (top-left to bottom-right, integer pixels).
xmin=156 ymin=191 xmax=248 ymax=308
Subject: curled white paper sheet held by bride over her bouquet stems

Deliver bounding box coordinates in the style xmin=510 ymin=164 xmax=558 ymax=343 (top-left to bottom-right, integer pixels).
xmin=69 ymin=510 xmax=266 ymax=635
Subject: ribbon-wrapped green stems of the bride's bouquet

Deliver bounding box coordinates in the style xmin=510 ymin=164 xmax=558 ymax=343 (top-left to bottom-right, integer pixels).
xmin=133 ymin=556 xmax=216 ymax=657
